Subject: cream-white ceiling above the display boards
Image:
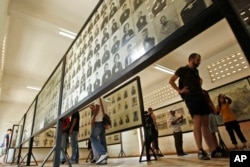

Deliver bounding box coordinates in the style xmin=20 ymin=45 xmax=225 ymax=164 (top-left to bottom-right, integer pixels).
xmin=0 ymin=0 xmax=246 ymax=120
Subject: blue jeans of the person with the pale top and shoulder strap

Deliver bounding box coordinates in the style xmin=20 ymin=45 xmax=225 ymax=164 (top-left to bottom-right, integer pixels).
xmin=90 ymin=122 xmax=107 ymax=155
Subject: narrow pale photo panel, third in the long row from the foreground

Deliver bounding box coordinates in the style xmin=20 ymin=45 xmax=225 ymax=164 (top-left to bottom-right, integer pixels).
xmin=22 ymin=100 xmax=36 ymax=142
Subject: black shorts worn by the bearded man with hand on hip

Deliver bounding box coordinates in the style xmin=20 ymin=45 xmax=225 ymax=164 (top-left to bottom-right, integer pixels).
xmin=184 ymin=94 xmax=211 ymax=117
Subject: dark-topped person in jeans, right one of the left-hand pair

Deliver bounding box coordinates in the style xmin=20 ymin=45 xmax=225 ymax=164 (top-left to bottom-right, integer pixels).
xmin=69 ymin=111 xmax=80 ymax=164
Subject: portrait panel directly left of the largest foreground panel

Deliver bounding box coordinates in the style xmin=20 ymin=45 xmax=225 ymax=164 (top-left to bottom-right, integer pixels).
xmin=32 ymin=63 xmax=62 ymax=134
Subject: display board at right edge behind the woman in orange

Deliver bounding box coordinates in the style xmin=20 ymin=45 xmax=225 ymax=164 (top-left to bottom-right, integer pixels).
xmin=209 ymin=78 xmax=250 ymax=125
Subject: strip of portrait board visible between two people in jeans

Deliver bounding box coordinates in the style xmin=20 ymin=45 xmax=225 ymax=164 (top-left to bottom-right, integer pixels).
xmin=78 ymin=107 xmax=91 ymax=141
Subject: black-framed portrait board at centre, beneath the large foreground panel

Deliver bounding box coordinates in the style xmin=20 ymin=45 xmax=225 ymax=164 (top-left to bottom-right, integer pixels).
xmin=103 ymin=77 xmax=144 ymax=134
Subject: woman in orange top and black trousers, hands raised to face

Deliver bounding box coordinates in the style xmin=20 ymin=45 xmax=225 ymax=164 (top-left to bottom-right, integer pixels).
xmin=216 ymin=94 xmax=248 ymax=150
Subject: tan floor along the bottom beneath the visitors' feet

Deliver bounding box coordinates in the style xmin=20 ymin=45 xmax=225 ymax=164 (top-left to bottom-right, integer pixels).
xmin=2 ymin=154 xmax=229 ymax=167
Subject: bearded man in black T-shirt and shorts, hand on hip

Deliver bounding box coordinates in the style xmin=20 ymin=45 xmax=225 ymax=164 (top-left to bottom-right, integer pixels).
xmin=169 ymin=53 xmax=222 ymax=160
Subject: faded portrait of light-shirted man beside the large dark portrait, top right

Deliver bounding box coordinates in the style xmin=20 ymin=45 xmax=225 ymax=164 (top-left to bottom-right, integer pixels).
xmin=160 ymin=16 xmax=180 ymax=39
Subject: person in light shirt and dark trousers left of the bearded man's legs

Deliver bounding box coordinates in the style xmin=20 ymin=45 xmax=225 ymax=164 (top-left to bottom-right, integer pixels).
xmin=168 ymin=110 xmax=187 ymax=156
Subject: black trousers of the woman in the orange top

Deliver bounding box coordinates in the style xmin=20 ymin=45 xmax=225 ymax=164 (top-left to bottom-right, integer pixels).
xmin=225 ymin=121 xmax=247 ymax=144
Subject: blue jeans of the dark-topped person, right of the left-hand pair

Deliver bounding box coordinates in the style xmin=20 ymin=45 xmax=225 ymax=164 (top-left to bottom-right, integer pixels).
xmin=70 ymin=131 xmax=79 ymax=162
